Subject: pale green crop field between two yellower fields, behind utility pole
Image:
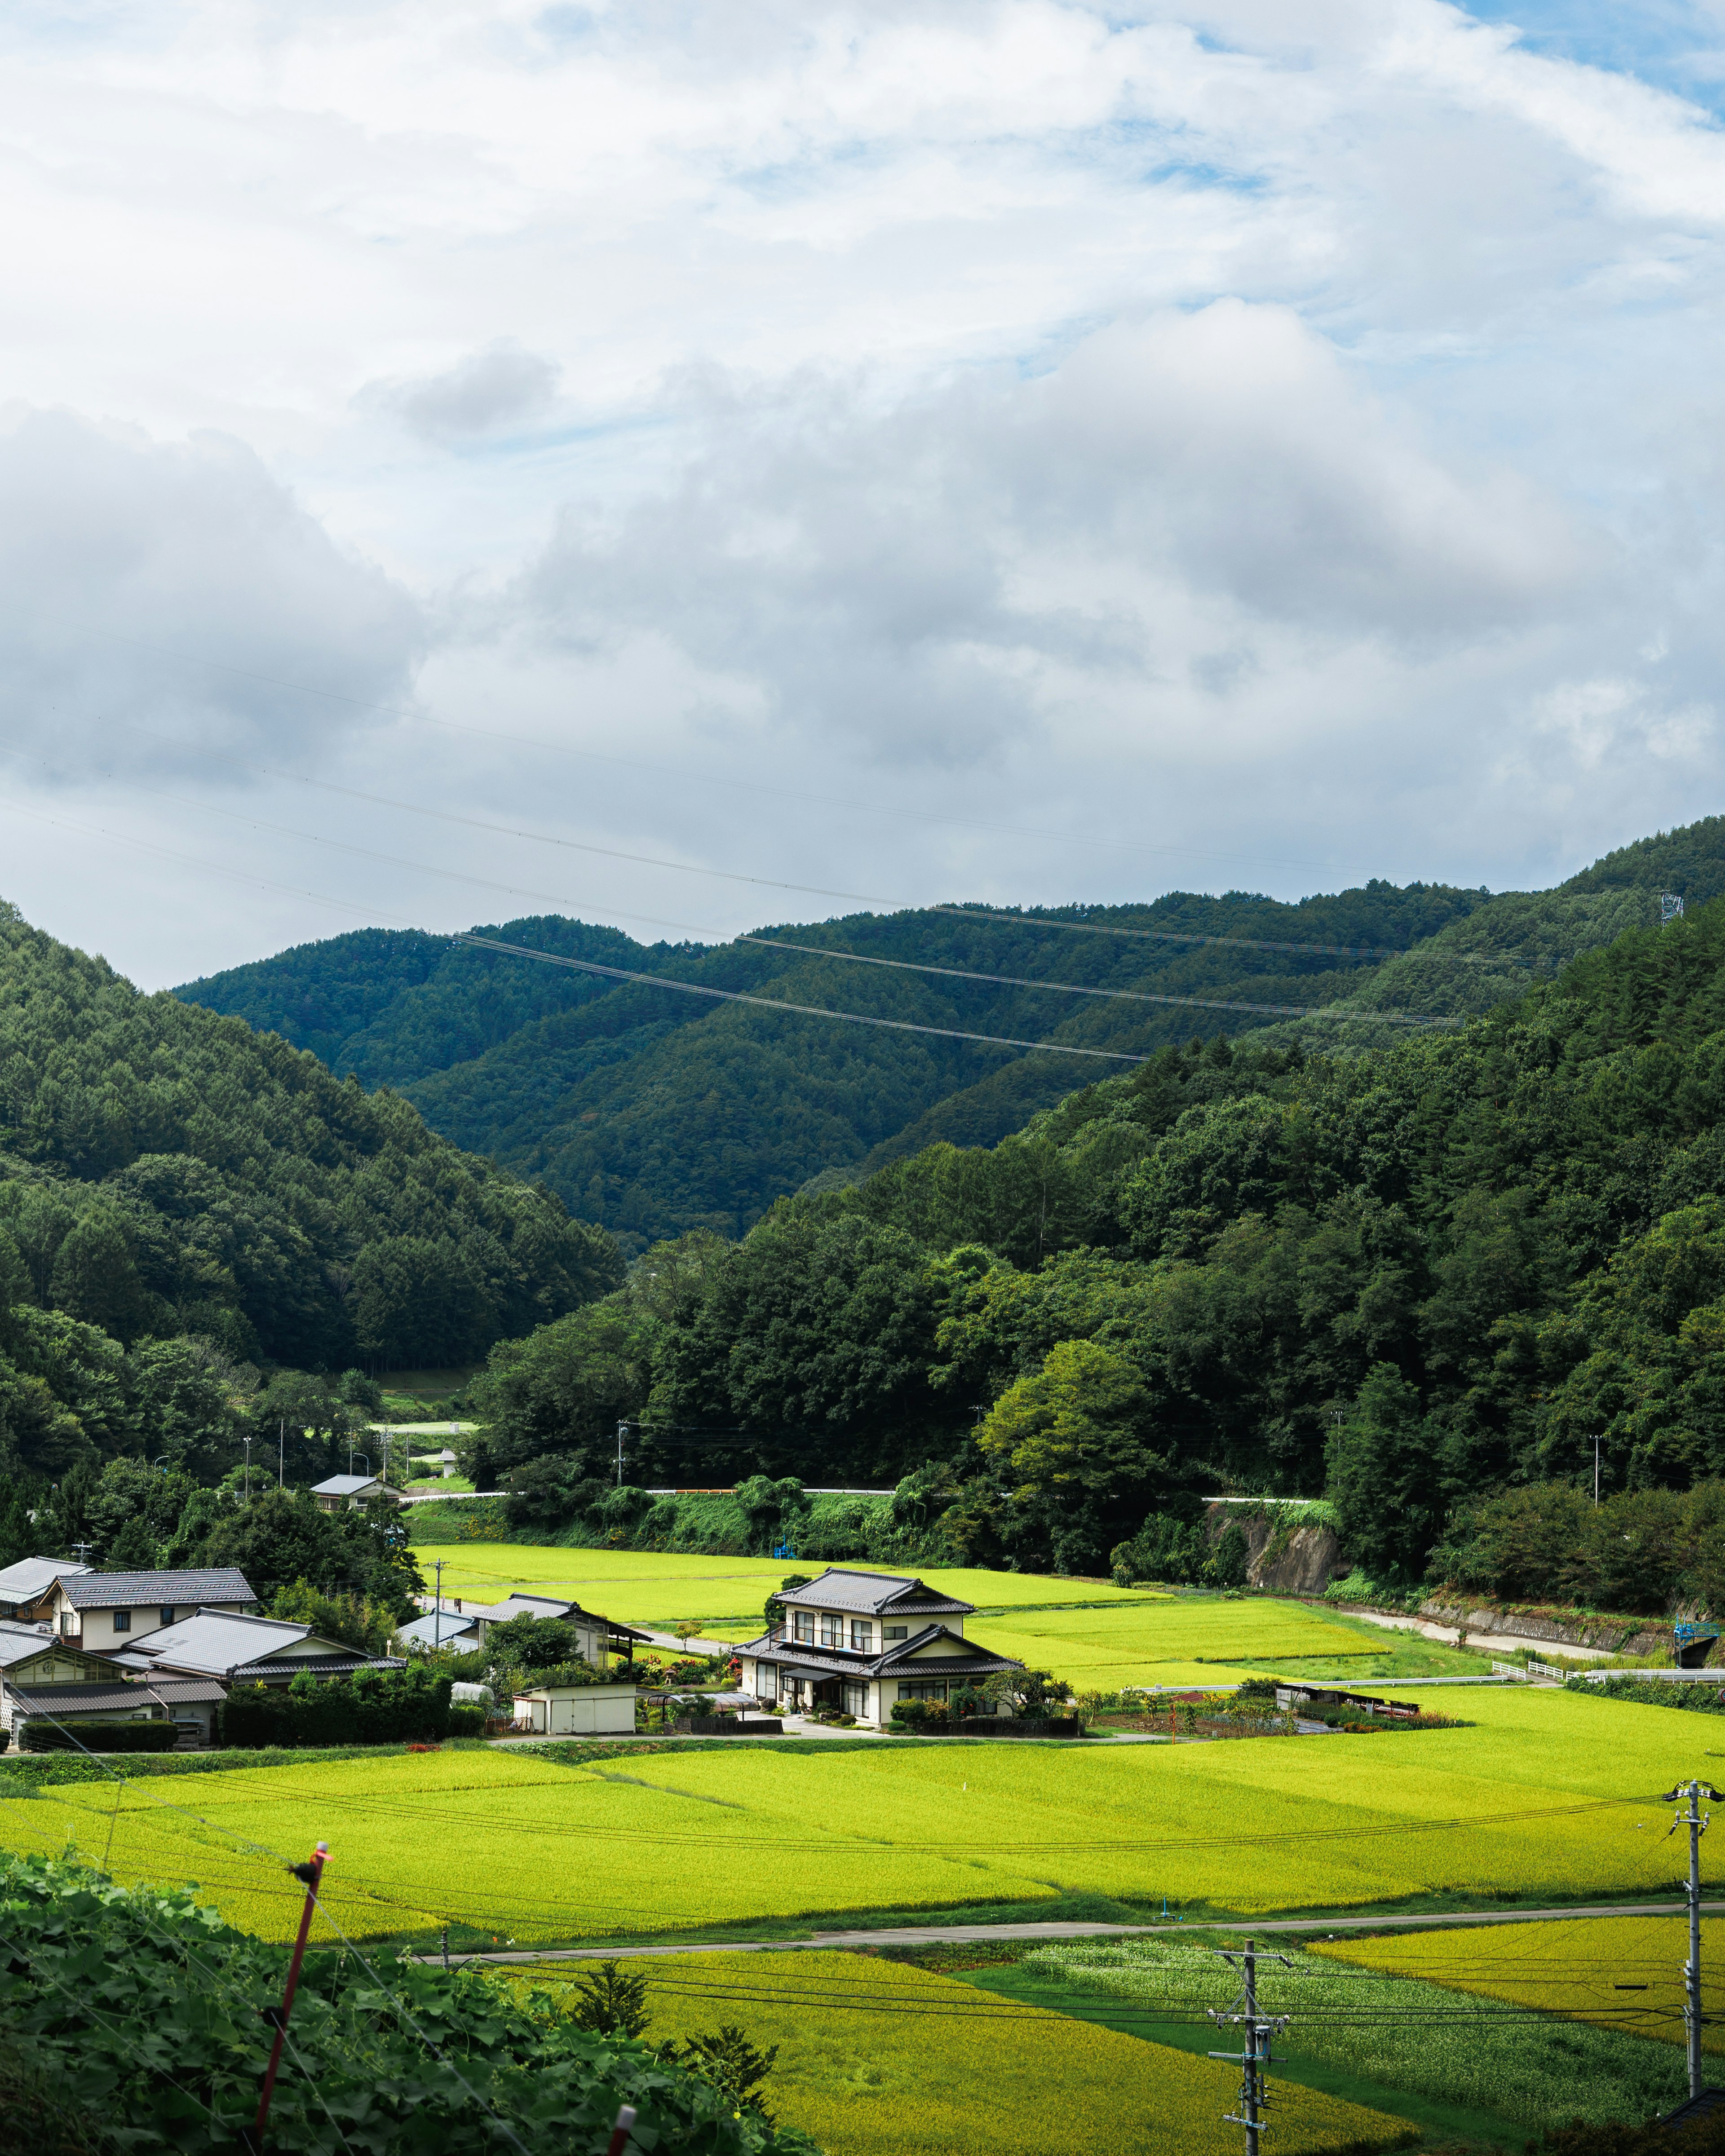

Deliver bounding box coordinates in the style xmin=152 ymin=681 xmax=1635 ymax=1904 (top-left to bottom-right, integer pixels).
xmin=1026 ymin=1925 xmax=1688 ymax=2128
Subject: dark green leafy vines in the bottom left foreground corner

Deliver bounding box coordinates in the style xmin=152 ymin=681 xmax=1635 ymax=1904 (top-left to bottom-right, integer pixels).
xmin=0 ymin=1859 xmax=813 ymax=2156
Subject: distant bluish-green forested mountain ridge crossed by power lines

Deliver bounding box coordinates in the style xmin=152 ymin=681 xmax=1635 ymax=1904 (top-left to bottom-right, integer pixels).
xmin=177 ymin=822 xmax=1725 ymax=1250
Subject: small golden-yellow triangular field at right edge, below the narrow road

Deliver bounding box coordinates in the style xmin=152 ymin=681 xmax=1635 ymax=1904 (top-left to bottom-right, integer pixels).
xmin=1313 ymin=1917 xmax=1725 ymax=2050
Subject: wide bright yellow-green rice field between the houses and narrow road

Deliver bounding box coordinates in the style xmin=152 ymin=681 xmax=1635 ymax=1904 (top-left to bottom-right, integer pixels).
xmin=0 ymin=1688 xmax=1725 ymax=1945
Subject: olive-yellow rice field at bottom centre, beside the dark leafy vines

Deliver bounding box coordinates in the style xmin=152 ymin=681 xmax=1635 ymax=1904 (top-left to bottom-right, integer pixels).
xmin=491 ymin=1953 xmax=1410 ymax=2156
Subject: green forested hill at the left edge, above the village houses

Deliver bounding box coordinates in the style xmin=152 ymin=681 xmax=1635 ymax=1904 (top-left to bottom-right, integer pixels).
xmin=0 ymin=906 xmax=621 ymax=1388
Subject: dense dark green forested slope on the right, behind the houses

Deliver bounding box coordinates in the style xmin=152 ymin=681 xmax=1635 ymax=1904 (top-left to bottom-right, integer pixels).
xmin=470 ymin=835 xmax=1725 ymax=1578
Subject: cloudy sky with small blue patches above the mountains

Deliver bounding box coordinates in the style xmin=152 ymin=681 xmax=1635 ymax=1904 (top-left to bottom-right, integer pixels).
xmin=0 ymin=0 xmax=1725 ymax=987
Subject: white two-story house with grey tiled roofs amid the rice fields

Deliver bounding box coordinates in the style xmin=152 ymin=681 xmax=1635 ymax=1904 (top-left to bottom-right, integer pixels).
xmin=738 ymin=1568 xmax=1024 ymax=1723
